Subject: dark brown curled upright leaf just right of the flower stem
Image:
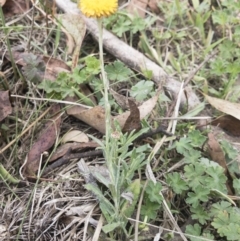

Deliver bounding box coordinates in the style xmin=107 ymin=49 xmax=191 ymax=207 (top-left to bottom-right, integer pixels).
xmin=122 ymin=100 xmax=142 ymax=133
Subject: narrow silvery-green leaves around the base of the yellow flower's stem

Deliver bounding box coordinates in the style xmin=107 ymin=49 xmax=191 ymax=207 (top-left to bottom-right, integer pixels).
xmin=85 ymin=129 xmax=150 ymax=239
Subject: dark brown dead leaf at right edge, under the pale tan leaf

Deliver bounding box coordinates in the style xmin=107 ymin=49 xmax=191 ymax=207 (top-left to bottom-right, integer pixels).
xmin=211 ymin=115 xmax=240 ymax=136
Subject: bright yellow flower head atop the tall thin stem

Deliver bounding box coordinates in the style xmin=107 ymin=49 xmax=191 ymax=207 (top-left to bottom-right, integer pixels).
xmin=78 ymin=0 xmax=118 ymax=18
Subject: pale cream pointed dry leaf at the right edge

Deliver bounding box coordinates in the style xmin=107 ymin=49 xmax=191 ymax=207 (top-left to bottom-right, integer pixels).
xmin=204 ymin=95 xmax=240 ymax=120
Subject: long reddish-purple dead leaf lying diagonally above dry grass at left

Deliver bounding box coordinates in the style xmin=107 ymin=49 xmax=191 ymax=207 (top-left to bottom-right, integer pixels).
xmin=24 ymin=104 xmax=61 ymax=176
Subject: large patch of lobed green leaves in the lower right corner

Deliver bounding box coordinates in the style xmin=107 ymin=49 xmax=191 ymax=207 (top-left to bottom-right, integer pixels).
xmin=166 ymin=130 xmax=240 ymax=241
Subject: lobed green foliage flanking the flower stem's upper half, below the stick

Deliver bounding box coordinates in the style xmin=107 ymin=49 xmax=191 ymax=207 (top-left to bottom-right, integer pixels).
xmin=38 ymin=56 xmax=133 ymax=106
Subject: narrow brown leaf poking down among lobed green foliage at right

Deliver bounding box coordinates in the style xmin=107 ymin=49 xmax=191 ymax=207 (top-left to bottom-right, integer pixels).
xmin=207 ymin=133 xmax=234 ymax=195
